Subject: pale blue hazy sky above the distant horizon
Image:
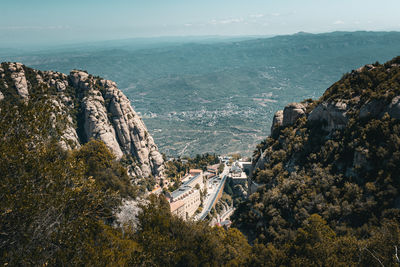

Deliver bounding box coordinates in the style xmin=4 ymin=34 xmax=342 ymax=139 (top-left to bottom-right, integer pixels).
xmin=0 ymin=0 xmax=400 ymax=47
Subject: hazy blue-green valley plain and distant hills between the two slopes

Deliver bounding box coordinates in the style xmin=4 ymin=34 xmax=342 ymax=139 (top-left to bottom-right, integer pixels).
xmin=0 ymin=32 xmax=400 ymax=155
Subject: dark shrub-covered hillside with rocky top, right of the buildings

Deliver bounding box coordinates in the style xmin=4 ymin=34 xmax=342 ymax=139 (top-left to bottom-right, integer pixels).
xmin=234 ymin=57 xmax=400 ymax=266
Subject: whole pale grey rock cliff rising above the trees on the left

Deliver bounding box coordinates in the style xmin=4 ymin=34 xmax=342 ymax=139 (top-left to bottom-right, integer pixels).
xmin=0 ymin=63 xmax=164 ymax=180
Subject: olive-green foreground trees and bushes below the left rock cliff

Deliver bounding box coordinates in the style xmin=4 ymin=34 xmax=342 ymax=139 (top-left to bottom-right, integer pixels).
xmin=0 ymin=99 xmax=250 ymax=266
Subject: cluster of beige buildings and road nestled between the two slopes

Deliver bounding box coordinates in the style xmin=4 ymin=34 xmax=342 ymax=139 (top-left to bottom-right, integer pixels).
xmin=149 ymin=156 xmax=252 ymax=227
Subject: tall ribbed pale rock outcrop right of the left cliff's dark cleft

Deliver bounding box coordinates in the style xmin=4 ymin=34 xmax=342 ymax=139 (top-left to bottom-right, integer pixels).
xmin=70 ymin=71 xmax=163 ymax=176
